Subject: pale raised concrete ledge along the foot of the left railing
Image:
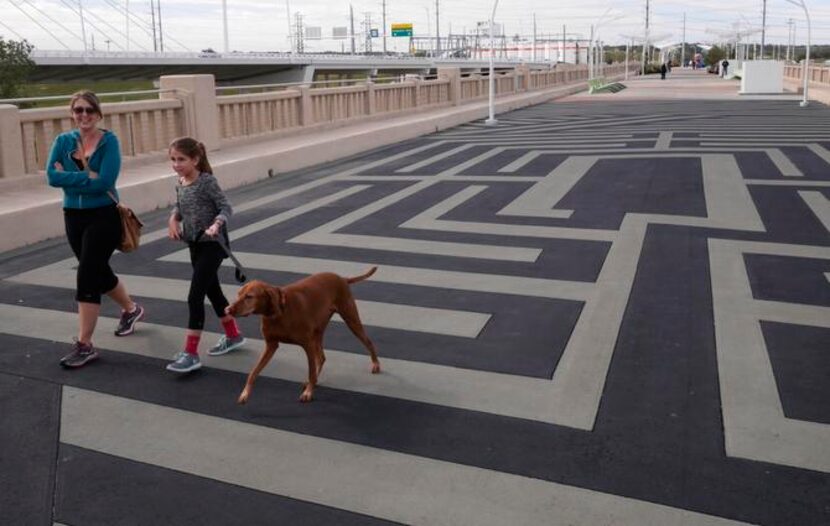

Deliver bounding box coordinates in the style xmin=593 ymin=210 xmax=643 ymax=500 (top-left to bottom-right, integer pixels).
xmin=0 ymin=81 xmax=587 ymax=252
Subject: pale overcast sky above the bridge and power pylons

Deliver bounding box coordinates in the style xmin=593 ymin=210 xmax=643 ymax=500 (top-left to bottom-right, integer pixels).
xmin=0 ymin=0 xmax=830 ymax=52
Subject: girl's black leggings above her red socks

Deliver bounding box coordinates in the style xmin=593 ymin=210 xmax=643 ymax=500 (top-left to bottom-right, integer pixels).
xmin=187 ymin=241 xmax=228 ymax=331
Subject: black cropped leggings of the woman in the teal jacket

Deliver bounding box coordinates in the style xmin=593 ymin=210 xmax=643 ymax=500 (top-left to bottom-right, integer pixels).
xmin=63 ymin=204 xmax=121 ymax=305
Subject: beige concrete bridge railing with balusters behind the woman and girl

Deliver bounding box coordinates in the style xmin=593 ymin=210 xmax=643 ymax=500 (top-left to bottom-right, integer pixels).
xmin=0 ymin=65 xmax=636 ymax=179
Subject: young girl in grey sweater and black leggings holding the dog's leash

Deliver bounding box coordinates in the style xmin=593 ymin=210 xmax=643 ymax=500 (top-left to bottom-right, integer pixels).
xmin=167 ymin=137 xmax=245 ymax=373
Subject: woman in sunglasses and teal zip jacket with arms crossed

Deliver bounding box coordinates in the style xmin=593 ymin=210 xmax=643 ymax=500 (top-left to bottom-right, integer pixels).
xmin=46 ymin=91 xmax=144 ymax=368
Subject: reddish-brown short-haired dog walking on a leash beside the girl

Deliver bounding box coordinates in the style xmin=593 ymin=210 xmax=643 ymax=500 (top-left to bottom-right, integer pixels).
xmin=225 ymin=267 xmax=380 ymax=404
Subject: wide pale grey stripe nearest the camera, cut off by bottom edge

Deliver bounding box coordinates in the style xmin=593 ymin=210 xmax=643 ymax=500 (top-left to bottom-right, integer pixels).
xmin=60 ymin=387 xmax=756 ymax=526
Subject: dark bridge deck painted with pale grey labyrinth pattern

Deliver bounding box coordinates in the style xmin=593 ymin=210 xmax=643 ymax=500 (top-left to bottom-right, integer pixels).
xmin=0 ymin=101 xmax=830 ymax=525
